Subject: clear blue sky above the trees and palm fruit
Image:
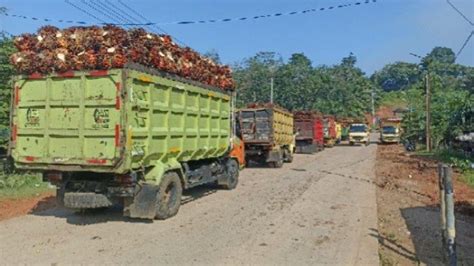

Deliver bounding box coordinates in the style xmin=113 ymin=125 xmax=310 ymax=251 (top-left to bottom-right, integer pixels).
xmin=0 ymin=0 xmax=474 ymax=75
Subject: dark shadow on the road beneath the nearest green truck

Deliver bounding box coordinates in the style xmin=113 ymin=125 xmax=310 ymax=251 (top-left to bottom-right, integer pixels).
xmin=30 ymin=183 xmax=219 ymax=225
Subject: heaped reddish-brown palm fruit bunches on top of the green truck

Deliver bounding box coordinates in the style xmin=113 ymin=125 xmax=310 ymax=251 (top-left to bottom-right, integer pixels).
xmin=10 ymin=25 xmax=234 ymax=89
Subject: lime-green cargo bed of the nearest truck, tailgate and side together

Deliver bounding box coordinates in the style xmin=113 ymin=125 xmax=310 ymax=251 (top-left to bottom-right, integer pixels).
xmin=11 ymin=69 xmax=231 ymax=173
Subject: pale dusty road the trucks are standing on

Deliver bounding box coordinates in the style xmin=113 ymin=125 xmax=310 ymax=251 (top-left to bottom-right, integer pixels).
xmin=0 ymin=140 xmax=379 ymax=265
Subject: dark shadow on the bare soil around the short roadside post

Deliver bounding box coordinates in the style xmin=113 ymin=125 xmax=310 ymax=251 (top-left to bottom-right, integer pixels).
xmin=401 ymin=206 xmax=474 ymax=265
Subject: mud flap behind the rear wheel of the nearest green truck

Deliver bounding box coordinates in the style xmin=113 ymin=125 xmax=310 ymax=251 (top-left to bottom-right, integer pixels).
xmin=124 ymin=183 xmax=158 ymax=219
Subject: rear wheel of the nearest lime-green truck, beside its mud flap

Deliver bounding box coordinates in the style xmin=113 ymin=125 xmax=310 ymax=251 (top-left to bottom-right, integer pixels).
xmin=155 ymin=172 xmax=183 ymax=220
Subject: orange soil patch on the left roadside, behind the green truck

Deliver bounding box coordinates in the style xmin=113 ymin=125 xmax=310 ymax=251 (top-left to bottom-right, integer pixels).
xmin=0 ymin=192 xmax=56 ymax=221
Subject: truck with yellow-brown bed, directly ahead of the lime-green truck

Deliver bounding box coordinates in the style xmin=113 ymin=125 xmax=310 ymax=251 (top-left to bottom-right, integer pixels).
xmin=237 ymin=104 xmax=295 ymax=168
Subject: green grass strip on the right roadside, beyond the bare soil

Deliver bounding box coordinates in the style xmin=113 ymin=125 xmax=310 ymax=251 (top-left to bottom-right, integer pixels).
xmin=416 ymin=149 xmax=474 ymax=188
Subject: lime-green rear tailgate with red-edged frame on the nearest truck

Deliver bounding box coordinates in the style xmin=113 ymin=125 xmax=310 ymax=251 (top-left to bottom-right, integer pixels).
xmin=11 ymin=70 xmax=123 ymax=169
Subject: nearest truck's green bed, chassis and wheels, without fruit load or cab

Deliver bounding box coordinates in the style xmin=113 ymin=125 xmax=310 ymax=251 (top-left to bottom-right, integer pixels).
xmin=9 ymin=65 xmax=239 ymax=219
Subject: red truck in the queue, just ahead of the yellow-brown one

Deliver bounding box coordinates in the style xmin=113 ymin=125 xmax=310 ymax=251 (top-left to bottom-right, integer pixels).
xmin=293 ymin=111 xmax=324 ymax=153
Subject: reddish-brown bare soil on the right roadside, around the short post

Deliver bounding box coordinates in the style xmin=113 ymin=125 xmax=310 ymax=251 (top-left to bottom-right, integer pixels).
xmin=376 ymin=145 xmax=474 ymax=265
